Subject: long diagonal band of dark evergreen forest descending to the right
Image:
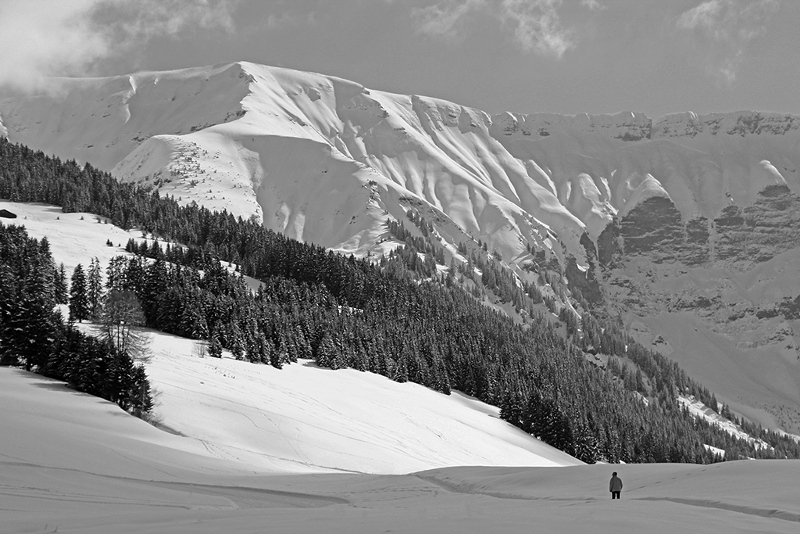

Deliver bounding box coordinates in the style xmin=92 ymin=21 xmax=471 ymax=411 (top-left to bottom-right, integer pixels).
xmin=0 ymin=140 xmax=800 ymax=463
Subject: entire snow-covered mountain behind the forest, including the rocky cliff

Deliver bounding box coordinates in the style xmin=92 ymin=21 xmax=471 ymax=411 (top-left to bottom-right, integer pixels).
xmin=0 ymin=62 xmax=800 ymax=431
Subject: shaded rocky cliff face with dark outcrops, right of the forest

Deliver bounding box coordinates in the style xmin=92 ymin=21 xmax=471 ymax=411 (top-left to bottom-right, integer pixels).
xmin=596 ymin=185 xmax=800 ymax=432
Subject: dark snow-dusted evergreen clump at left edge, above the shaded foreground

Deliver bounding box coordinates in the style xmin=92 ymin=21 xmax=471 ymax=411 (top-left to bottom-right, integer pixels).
xmin=0 ymin=224 xmax=152 ymax=417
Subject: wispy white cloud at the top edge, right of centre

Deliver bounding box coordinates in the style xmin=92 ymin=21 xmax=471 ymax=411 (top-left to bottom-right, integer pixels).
xmin=411 ymin=0 xmax=575 ymax=58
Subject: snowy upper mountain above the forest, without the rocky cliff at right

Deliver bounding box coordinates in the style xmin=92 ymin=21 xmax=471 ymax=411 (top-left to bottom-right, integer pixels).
xmin=0 ymin=61 xmax=800 ymax=264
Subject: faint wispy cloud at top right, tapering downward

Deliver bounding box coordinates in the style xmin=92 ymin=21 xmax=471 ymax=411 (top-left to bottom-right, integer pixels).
xmin=677 ymin=0 xmax=779 ymax=87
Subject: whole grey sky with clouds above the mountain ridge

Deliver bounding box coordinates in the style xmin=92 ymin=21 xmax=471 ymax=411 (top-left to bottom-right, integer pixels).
xmin=0 ymin=0 xmax=800 ymax=118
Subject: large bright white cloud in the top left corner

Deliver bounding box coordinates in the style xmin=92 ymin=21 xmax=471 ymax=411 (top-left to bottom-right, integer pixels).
xmin=0 ymin=0 xmax=234 ymax=89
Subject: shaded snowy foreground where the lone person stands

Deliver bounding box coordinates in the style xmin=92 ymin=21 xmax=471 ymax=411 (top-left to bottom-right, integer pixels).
xmin=0 ymin=368 xmax=800 ymax=534
